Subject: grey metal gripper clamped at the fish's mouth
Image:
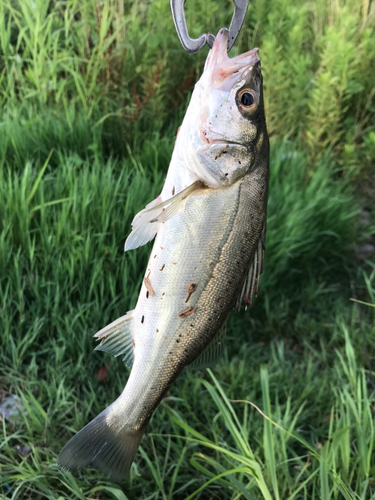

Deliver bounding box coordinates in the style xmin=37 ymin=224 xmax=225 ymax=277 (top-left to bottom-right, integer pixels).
xmin=171 ymin=0 xmax=249 ymax=54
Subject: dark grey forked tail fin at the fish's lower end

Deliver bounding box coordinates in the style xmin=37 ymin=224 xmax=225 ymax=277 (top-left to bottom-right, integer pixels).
xmin=57 ymin=403 xmax=147 ymax=482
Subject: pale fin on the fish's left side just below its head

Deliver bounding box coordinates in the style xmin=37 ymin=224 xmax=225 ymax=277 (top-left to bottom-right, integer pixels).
xmin=125 ymin=181 xmax=201 ymax=252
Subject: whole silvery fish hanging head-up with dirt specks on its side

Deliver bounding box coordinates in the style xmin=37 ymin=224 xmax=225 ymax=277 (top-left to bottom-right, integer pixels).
xmin=57 ymin=28 xmax=269 ymax=482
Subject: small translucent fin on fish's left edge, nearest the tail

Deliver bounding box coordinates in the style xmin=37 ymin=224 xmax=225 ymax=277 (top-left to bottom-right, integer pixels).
xmin=94 ymin=311 xmax=134 ymax=366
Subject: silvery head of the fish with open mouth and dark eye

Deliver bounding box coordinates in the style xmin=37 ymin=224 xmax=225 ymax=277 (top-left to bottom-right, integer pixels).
xmin=190 ymin=28 xmax=266 ymax=187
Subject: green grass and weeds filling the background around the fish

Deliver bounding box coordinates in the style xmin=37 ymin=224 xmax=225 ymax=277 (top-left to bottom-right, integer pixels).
xmin=0 ymin=0 xmax=375 ymax=500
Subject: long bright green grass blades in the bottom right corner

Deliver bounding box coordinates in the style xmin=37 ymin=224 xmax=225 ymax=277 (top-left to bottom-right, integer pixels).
xmin=168 ymin=322 xmax=374 ymax=500
